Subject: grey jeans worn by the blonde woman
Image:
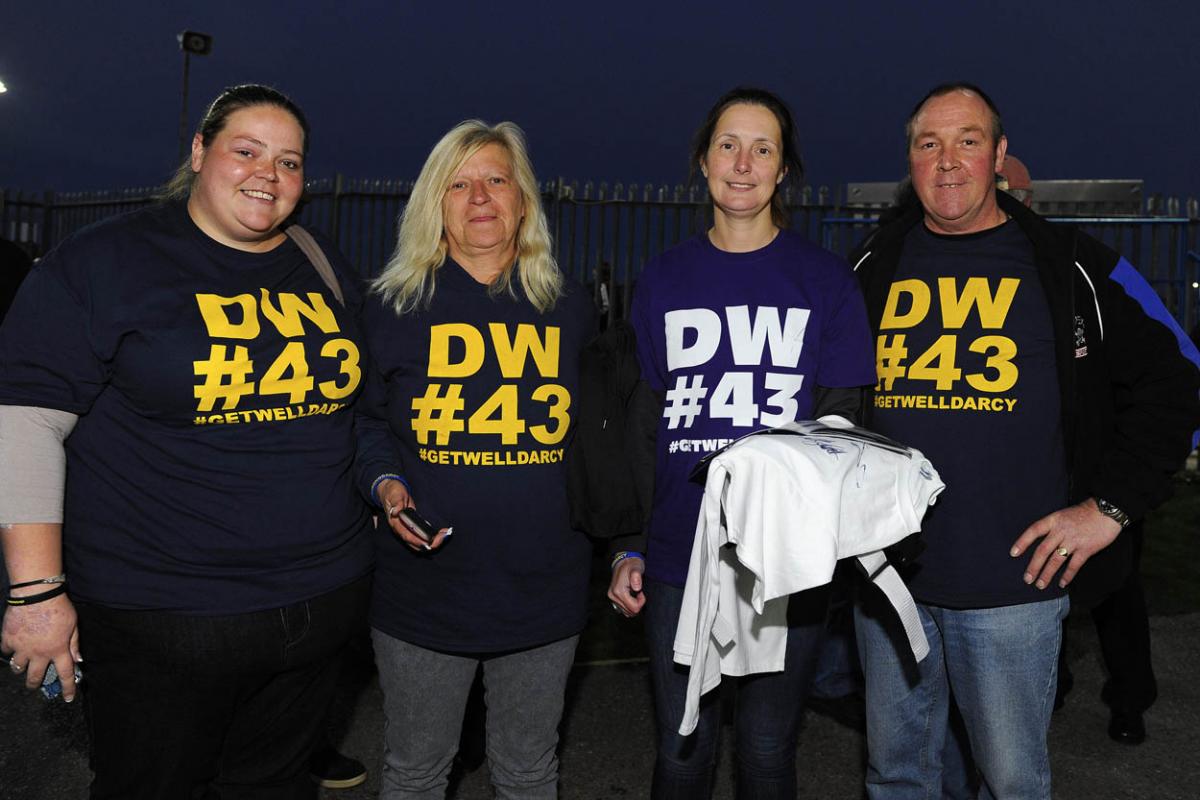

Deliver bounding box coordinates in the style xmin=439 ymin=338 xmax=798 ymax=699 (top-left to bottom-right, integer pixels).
xmin=371 ymin=628 xmax=580 ymax=800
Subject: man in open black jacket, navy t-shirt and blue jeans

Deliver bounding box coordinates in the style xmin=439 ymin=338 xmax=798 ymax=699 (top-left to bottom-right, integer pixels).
xmin=851 ymin=83 xmax=1200 ymax=800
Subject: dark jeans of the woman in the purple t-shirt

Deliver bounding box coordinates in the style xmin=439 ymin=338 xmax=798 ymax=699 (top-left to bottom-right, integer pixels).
xmin=644 ymin=579 xmax=829 ymax=800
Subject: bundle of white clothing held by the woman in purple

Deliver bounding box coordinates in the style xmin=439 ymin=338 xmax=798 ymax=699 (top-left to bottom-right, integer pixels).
xmin=674 ymin=416 xmax=946 ymax=735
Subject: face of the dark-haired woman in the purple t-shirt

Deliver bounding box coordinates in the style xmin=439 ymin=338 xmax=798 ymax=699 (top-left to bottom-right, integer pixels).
xmin=700 ymin=103 xmax=785 ymax=226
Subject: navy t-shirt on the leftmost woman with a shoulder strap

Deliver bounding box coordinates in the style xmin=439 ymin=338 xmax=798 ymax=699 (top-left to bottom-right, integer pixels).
xmin=0 ymin=204 xmax=372 ymax=614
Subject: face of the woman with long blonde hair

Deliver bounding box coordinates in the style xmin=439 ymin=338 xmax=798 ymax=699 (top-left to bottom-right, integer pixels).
xmin=442 ymin=144 xmax=524 ymax=271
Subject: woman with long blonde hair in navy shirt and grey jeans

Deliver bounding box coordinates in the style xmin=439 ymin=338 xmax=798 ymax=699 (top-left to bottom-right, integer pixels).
xmin=359 ymin=120 xmax=595 ymax=799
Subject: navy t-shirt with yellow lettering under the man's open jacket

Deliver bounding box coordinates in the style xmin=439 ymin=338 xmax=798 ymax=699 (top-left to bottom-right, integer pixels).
xmin=872 ymin=222 xmax=1067 ymax=608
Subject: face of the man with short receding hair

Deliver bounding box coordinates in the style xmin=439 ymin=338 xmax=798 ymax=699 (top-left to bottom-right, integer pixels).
xmin=908 ymin=90 xmax=1008 ymax=234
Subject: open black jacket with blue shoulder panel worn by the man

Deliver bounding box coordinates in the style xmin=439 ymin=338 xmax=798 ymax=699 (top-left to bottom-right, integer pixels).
xmin=850 ymin=192 xmax=1200 ymax=604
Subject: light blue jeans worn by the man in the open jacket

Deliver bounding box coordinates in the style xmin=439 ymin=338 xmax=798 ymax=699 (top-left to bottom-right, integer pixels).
xmin=854 ymin=588 xmax=1069 ymax=800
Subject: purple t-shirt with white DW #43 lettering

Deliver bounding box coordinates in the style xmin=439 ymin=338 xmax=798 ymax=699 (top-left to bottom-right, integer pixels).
xmin=631 ymin=230 xmax=875 ymax=587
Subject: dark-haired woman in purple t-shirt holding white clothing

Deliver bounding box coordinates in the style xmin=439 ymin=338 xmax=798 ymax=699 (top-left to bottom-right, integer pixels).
xmin=608 ymin=88 xmax=875 ymax=800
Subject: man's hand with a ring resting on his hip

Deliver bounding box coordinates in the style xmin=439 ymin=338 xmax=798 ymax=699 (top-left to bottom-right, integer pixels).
xmin=1009 ymin=498 xmax=1121 ymax=589
